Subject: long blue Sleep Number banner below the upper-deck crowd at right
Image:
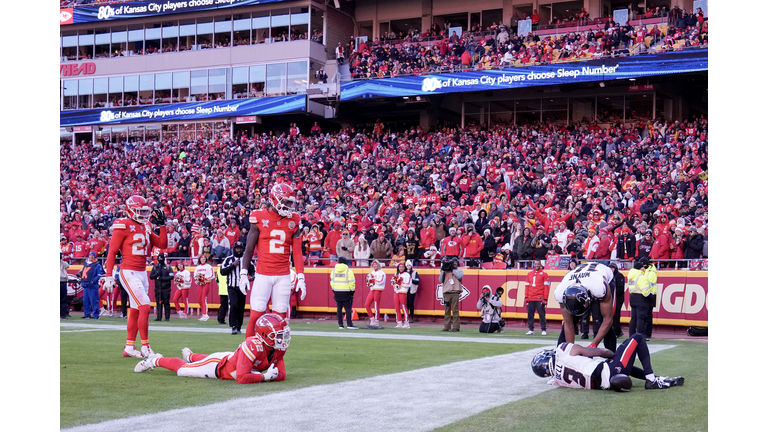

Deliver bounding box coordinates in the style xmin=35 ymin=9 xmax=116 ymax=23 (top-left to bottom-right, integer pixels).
xmin=341 ymin=49 xmax=709 ymax=101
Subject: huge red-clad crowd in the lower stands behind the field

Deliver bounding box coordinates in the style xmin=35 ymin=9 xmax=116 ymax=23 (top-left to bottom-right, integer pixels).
xmin=60 ymin=117 xmax=708 ymax=267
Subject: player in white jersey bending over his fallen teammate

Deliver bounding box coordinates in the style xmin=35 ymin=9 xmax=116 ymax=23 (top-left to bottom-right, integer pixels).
xmin=555 ymin=262 xmax=616 ymax=351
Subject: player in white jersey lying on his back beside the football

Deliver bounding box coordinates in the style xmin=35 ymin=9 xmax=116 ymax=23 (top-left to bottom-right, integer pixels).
xmin=531 ymin=333 xmax=684 ymax=390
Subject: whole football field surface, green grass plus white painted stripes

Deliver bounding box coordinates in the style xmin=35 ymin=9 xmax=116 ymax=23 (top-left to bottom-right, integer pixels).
xmin=60 ymin=315 xmax=708 ymax=431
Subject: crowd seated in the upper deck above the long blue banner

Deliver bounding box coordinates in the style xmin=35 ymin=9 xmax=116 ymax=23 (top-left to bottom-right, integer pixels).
xmin=347 ymin=13 xmax=708 ymax=79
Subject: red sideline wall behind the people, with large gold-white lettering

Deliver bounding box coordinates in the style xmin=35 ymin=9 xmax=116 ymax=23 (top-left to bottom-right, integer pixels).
xmin=68 ymin=266 xmax=709 ymax=326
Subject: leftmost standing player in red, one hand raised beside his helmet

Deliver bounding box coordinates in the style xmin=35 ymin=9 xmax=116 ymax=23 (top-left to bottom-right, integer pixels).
xmin=104 ymin=195 xmax=168 ymax=358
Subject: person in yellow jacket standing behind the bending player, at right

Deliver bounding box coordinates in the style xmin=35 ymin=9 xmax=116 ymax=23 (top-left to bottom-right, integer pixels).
xmin=627 ymin=257 xmax=657 ymax=338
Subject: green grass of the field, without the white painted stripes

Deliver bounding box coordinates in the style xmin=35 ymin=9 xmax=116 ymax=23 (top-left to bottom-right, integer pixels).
xmin=60 ymin=318 xmax=708 ymax=431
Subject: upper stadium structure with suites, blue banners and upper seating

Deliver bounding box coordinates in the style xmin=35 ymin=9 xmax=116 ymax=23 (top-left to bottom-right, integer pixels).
xmin=60 ymin=0 xmax=707 ymax=144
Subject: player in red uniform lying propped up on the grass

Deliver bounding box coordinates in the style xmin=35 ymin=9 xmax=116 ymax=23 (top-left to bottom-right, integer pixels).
xmin=133 ymin=313 xmax=291 ymax=384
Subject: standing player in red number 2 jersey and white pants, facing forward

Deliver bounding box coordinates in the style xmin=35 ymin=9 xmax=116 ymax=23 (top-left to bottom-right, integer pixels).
xmin=240 ymin=183 xmax=307 ymax=338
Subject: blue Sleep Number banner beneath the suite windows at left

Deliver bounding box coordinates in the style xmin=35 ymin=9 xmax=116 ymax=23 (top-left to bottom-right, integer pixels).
xmin=59 ymin=95 xmax=306 ymax=126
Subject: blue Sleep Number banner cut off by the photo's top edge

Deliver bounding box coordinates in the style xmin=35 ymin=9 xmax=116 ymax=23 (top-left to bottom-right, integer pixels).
xmin=59 ymin=0 xmax=286 ymax=25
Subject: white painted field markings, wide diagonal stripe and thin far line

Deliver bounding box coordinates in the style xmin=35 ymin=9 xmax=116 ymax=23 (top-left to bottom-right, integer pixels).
xmin=64 ymin=324 xmax=673 ymax=432
